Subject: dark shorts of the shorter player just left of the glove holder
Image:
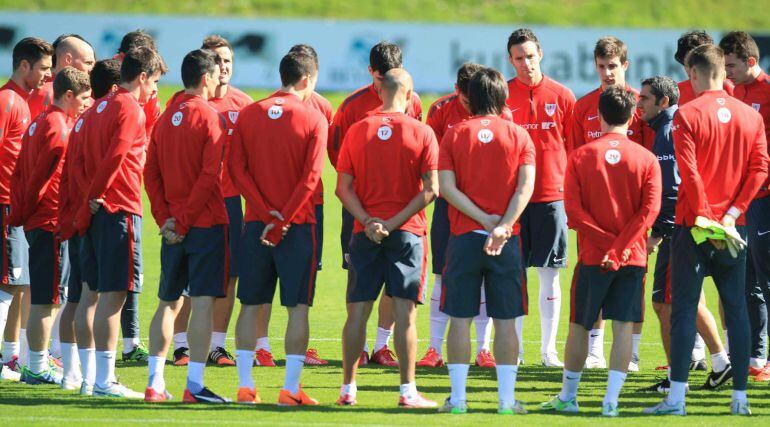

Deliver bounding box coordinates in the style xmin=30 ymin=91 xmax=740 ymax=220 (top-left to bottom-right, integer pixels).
xmin=568 ymin=263 xmax=645 ymax=330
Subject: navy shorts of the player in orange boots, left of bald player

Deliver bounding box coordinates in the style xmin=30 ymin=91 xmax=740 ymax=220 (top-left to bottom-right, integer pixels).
xmin=238 ymin=221 xmax=318 ymax=307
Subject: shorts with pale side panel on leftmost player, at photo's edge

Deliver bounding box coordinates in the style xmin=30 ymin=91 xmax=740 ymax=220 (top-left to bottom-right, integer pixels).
xmin=0 ymin=205 xmax=29 ymax=286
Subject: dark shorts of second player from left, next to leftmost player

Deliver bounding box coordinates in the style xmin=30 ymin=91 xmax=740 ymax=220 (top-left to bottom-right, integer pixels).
xmin=25 ymin=228 xmax=70 ymax=305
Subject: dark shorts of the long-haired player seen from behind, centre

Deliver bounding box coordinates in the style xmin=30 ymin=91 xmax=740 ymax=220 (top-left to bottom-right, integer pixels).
xmin=441 ymin=232 xmax=527 ymax=319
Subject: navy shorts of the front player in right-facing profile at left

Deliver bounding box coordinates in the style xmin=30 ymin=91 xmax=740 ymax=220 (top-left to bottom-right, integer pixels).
xmin=80 ymin=208 xmax=144 ymax=293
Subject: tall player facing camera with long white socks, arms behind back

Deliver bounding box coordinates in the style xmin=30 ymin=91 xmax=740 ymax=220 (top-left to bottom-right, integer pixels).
xmin=507 ymin=28 xmax=575 ymax=367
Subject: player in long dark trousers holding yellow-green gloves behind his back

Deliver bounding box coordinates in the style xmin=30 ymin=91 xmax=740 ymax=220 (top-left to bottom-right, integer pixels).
xmin=645 ymin=45 xmax=767 ymax=415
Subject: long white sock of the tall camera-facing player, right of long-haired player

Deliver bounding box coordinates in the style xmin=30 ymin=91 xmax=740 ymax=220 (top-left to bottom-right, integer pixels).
xmin=536 ymin=267 xmax=561 ymax=354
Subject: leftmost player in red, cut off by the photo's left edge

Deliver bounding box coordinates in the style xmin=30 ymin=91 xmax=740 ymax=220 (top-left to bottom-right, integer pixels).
xmin=0 ymin=37 xmax=53 ymax=379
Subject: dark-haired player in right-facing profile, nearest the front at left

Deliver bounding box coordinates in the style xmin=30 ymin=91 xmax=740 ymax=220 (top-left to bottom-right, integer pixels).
xmin=75 ymin=47 xmax=166 ymax=399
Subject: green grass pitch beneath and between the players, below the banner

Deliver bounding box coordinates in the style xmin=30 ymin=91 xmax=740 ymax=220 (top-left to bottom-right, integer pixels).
xmin=0 ymin=87 xmax=770 ymax=426
